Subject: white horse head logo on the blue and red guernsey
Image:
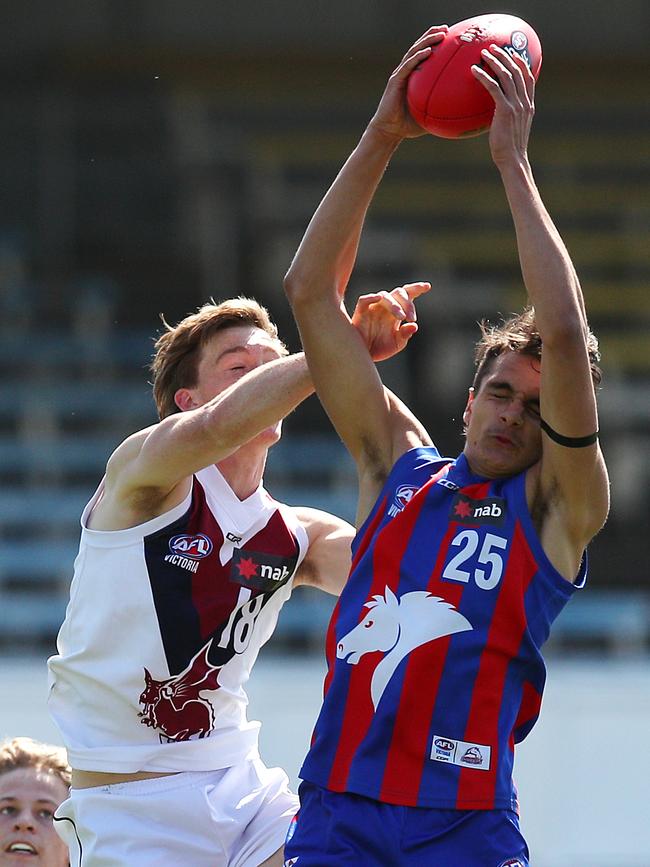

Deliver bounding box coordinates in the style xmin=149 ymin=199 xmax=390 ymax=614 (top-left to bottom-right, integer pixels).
xmin=336 ymin=587 xmax=473 ymax=710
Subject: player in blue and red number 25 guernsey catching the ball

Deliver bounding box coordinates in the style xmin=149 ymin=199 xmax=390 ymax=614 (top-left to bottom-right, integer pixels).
xmin=285 ymin=28 xmax=608 ymax=867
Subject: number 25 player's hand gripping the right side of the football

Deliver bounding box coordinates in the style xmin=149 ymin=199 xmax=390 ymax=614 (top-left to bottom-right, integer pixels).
xmin=472 ymin=44 xmax=535 ymax=167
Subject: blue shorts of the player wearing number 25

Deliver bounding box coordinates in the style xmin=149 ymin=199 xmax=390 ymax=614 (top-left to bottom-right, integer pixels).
xmin=284 ymin=783 xmax=529 ymax=867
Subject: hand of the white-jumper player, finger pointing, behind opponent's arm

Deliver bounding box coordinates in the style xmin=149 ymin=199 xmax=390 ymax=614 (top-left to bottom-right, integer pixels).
xmin=352 ymin=283 xmax=431 ymax=361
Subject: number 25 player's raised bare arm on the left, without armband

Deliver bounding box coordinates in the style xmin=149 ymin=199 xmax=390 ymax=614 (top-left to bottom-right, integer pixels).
xmin=285 ymin=28 xmax=445 ymax=521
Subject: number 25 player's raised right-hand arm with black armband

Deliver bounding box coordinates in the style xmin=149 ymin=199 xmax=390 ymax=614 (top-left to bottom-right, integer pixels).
xmin=474 ymin=47 xmax=609 ymax=580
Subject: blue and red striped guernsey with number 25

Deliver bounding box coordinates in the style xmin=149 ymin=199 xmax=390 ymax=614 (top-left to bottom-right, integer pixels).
xmin=300 ymin=447 xmax=586 ymax=810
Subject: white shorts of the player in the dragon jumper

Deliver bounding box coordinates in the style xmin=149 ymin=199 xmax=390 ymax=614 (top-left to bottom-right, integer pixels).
xmin=54 ymin=758 xmax=298 ymax=867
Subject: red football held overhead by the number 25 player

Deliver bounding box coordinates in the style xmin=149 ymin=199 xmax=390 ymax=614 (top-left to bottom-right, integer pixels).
xmin=407 ymin=13 xmax=542 ymax=138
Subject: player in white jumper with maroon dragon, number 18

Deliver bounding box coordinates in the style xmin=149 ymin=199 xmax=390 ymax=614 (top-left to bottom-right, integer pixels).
xmin=48 ymin=293 xmax=416 ymax=867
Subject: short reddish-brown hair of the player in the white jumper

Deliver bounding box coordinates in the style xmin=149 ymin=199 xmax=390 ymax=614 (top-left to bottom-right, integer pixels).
xmin=151 ymin=296 xmax=286 ymax=419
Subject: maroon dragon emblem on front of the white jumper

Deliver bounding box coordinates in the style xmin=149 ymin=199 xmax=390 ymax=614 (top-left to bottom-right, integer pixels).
xmin=138 ymin=639 xmax=221 ymax=742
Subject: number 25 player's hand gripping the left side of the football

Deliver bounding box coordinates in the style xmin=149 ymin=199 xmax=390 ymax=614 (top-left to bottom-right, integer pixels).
xmin=368 ymin=24 xmax=448 ymax=142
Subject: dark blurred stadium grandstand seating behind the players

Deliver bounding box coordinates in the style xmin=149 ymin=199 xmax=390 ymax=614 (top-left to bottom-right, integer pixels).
xmin=0 ymin=0 xmax=650 ymax=653
